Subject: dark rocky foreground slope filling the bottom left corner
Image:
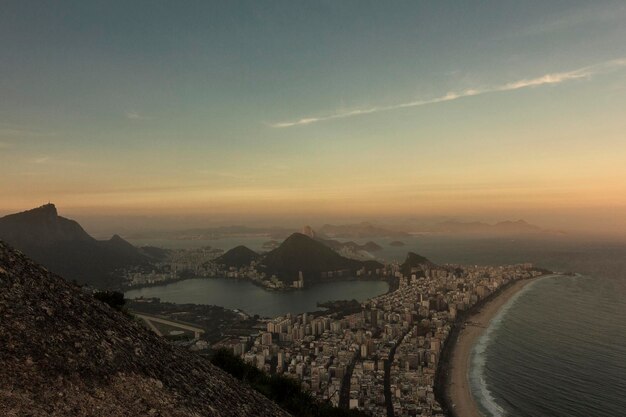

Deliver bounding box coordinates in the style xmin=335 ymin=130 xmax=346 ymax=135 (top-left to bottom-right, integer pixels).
xmin=0 ymin=242 xmax=288 ymax=417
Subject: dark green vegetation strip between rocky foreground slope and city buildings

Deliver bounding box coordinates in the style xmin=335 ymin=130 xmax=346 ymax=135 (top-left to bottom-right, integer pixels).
xmin=211 ymin=349 xmax=366 ymax=417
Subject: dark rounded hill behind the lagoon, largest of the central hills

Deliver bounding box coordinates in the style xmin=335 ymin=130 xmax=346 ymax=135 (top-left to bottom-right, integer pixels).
xmin=259 ymin=233 xmax=383 ymax=282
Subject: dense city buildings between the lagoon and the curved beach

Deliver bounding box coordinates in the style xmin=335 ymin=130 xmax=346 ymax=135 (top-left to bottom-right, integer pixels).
xmin=214 ymin=264 xmax=541 ymax=416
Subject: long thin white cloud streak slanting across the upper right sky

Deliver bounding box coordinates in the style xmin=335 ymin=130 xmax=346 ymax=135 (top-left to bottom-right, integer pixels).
xmin=269 ymin=58 xmax=626 ymax=128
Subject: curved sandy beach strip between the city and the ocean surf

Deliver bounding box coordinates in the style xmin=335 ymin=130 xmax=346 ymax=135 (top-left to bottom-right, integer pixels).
xmin=447 ymin=278 xmax=537 ymax=417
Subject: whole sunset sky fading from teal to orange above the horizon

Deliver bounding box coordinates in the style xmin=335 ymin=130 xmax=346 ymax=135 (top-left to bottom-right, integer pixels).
xmin=0 ymin=0 xmax=626 ymax=233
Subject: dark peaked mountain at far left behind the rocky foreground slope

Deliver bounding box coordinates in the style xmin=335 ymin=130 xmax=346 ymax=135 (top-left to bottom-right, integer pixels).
xmin=0 ymin=204 xmax=152 ymax=289
